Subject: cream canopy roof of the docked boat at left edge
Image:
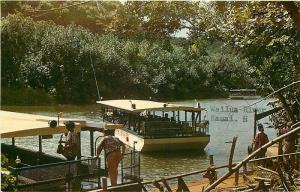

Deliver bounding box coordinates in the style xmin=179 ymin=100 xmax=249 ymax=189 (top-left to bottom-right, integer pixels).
xmin=0 ymin=111 xmax=81 ymax=138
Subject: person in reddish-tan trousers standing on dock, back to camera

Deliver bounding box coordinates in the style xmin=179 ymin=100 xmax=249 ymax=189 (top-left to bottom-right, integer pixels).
xmin=97 ymin=129 xmax=126 ymax=186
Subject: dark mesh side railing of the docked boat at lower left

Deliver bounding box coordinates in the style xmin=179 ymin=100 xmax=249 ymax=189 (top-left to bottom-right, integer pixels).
xmin=9 ymin=158 xmax=105 ymax=191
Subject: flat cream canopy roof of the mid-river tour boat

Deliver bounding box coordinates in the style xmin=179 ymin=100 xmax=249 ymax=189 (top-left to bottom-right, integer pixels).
xmin=97 ymin=99 xmax=206 ymax=112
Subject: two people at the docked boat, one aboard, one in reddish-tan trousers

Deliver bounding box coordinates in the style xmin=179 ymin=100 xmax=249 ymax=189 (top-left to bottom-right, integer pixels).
xmin=57 ymin=121 xmax=126 ymax=186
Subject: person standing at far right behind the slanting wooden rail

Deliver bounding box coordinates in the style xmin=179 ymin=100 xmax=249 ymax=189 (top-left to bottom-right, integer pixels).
xmin=253 ymin=124 xmax=269 ymax=158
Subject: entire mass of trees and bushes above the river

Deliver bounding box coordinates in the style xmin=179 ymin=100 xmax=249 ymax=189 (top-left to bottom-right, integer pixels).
xmin=1 ymin=1 xmax=300 ymax=104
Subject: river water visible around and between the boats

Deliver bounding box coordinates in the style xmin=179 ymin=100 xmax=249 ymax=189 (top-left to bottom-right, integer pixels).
xmin=1 ymin=99 xmax=276 ymax=183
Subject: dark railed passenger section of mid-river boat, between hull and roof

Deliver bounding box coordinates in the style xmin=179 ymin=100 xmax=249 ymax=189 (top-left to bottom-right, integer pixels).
xmin=140 ymin=121 xmax=209 ymax=137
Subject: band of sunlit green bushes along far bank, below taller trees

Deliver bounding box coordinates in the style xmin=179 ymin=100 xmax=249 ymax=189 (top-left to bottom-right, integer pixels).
xmin=1 ymin=15 xmax=255 ymax=103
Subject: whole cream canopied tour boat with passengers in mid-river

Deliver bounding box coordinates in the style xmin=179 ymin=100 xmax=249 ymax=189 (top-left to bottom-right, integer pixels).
xmin=97 ymin=100 xmax=210 ymax=152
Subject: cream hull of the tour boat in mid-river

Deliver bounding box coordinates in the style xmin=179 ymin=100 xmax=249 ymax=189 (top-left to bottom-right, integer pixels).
xmin=115 ymin=129 xmax=210 ymax=152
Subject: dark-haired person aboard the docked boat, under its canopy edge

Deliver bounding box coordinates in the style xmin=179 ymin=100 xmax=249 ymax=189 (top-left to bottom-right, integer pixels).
xmin=60 ymin=121 xmax=80 ymax=160
